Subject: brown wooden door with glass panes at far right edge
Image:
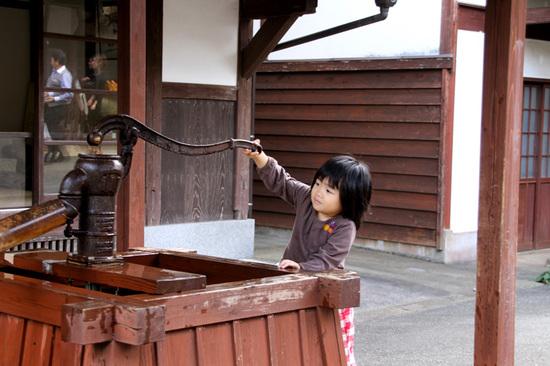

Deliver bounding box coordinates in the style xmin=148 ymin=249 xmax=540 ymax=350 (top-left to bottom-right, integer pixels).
xmin=518 ymin=83 xmax=550 ymax=251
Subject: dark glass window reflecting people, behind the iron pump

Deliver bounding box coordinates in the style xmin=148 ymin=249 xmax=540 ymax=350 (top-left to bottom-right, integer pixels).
xmin=43 ymin=0 xmax=118 ymax=194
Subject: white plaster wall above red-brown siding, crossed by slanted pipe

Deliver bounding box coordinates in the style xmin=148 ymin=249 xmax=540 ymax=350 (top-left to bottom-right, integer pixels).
xmin=264 ymin=0 xmax=442 ymax=60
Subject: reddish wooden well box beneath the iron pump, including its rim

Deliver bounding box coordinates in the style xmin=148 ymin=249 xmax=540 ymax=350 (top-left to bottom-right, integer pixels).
xmin=0 ymin=248 xmax=359 ymax=366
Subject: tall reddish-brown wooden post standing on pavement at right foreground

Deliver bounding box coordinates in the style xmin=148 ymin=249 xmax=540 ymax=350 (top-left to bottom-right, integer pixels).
xmin=474 ymin=0 xmax=527 ymax=365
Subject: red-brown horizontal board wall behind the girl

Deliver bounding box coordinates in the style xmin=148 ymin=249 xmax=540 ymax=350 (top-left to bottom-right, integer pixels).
xmin=253 ymin=59 xmax=451 ymax=247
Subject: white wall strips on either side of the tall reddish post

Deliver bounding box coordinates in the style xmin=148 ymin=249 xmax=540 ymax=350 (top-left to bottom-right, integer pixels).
xmin=443 ymin=10 xmax=550 ymax=261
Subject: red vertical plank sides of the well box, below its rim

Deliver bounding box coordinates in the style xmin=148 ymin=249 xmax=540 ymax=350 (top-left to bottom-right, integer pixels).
xmin=0 ymin=307 xmax=345 ymax=366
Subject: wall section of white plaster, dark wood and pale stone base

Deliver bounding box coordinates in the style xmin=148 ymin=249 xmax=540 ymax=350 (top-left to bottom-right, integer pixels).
xmin=145 ymin=0 xmax=254 ymax=258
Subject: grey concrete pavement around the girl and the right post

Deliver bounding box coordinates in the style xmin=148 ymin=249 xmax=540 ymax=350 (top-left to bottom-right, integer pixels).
xmin=254 ymin=232 xmax=550 ymax=366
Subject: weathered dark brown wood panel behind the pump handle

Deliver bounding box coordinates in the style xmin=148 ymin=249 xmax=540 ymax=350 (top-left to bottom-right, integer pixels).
xmin=160 ymin=98 xmax=235 ymax=225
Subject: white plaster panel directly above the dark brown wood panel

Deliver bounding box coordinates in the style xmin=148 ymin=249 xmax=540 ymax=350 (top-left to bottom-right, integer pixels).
xmin=162 ymin=0 xmax=239 ymax=86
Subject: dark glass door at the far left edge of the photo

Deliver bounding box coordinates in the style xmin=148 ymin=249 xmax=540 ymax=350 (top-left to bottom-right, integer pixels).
xmin=0 ymin=2 xmax=34 ymax=209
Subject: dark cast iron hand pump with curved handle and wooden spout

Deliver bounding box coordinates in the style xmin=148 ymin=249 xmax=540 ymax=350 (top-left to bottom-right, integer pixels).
xmin=0 ymin=115 xmax=261 ymax=266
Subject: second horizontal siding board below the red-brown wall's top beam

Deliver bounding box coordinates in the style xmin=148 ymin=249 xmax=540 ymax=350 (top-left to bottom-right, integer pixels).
xmin=255 ymin=85 xmax=441 ymax=105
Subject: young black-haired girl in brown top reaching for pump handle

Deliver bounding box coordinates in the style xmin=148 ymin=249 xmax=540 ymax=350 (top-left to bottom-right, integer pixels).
xmin=244 ymin=140 xmax=372 ymax=365
